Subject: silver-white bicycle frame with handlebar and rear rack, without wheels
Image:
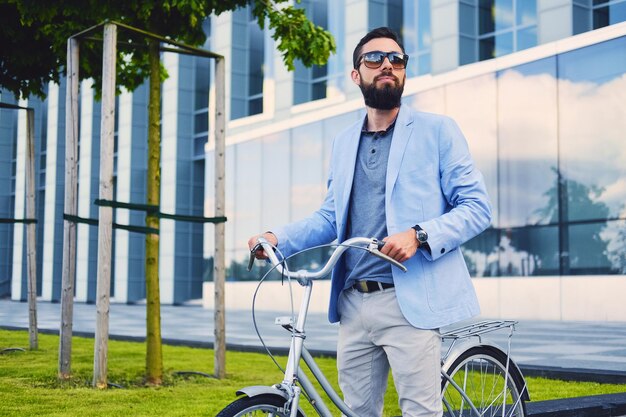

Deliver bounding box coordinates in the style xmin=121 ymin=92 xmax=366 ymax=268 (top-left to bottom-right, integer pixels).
xmin=237 ymin=237 xmax=528 ymax=417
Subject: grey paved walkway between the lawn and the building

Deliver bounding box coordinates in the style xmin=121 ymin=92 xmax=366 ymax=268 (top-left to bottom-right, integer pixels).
xmin=0 ymin=300 xmax=626 ymax=382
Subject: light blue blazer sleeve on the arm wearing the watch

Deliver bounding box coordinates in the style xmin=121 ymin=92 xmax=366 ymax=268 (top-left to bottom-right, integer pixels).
xmin=420 ymin=117 xmax=491 ymax=261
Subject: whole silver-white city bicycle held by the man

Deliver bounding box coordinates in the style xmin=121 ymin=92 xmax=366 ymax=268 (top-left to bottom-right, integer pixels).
xmin=216 ymin=237 xmax=530 ymax=417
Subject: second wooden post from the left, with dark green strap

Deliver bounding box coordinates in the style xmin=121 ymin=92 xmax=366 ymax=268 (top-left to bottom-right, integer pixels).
xmin=58 ymin=38 xmax=79 ymax=379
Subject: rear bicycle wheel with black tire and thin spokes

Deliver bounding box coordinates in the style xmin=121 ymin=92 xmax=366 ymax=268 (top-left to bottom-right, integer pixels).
xmin=441 ymin=346 xmax=527 ymax=417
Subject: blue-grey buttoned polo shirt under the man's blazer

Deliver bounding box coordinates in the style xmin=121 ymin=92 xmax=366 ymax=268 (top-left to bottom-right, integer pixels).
xmin=344 ymin=119 xmax=395 ymax=288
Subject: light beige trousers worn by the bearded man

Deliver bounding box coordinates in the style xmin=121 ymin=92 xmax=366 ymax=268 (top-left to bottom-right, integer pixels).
xmin=337 ymin=288 xmax=442 ymax=417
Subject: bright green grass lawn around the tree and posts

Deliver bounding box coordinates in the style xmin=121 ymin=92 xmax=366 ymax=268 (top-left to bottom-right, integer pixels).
xmin=0 ymin=330 xmax=626 ymax=417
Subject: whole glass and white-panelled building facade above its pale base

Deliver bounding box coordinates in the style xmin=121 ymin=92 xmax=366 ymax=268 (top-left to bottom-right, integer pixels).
xmin=0 ymin=0 xmax=626 ymax=304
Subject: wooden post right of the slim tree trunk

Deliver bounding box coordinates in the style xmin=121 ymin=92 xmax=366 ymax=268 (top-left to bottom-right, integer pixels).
xmin=213 ymin=58 xmax=226 ymax=379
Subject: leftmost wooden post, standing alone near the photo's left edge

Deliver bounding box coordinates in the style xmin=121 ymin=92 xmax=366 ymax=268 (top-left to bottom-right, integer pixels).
xmin=26 ymin=109 xmax=39 ymax=350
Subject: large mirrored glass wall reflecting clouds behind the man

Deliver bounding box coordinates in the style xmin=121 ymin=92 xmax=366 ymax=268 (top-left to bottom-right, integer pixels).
xmin=207 ymin=26 xmax=626 ymax=280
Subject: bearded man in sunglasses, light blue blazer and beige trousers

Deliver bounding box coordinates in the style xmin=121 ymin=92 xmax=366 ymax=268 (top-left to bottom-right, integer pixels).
xmin=248 ymin=28 xmax=491 ymax=417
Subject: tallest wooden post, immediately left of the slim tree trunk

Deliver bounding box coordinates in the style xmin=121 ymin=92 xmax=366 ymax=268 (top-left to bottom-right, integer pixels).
xmin=93 ymin=23 xmax=117 ymax=388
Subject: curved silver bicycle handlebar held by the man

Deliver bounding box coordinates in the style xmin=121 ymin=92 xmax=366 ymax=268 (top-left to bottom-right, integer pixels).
xmin=248 ymin=237 xmax=407 ymax=279
